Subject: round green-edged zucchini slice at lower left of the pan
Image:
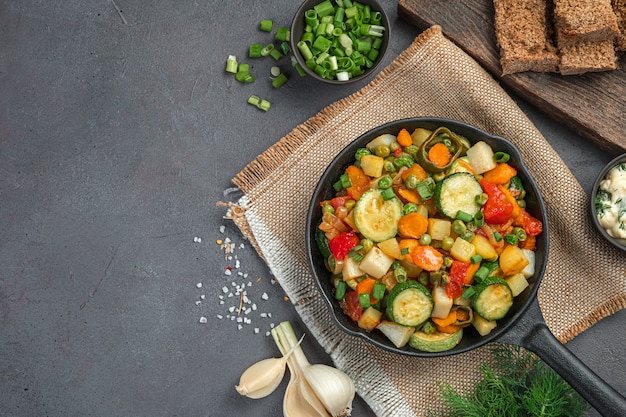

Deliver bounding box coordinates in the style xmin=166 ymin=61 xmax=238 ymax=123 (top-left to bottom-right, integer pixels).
xmin=387 ymin=281 xmax=435 ymax=327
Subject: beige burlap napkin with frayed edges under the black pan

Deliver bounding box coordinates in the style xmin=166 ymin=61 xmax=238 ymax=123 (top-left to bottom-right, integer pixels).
xmin=222 ymin=26 xmax=626 ymax=417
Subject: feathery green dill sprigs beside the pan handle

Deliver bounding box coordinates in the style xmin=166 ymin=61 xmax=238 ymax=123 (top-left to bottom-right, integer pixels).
xmin=428 ymin=344 xmax=589 ymax=417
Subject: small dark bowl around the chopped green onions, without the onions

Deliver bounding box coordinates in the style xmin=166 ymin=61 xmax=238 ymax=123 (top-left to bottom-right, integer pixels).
xmin=290 ymin=0 xmax=391 ymax=85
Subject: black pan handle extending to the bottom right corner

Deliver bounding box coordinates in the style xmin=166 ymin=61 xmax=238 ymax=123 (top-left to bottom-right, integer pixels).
xmin=498 ymin=297 xmax=626 ymax=417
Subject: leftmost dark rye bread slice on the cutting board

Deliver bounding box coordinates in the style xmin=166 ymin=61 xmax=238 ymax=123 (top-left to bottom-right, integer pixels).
xmin=493 ymin=0 xmax=560 ymax=75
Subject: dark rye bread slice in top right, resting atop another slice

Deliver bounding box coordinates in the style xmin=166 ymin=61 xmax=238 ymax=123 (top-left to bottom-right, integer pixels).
xmin=554 ymin=0 xmax=620 ymax=48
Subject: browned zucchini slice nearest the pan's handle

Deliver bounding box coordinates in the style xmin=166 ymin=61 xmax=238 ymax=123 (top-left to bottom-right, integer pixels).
xmin=472 ymin=277 xmax=513 ymax=321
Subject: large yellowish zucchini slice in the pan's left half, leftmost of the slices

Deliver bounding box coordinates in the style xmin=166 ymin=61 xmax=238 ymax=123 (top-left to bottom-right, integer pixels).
xmin=354 ymin=188 xmax=402 ymax=242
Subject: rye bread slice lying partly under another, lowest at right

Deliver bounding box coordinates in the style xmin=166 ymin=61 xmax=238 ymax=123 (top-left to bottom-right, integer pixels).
xmin=559 ymin=40 xmax=617 ymax=75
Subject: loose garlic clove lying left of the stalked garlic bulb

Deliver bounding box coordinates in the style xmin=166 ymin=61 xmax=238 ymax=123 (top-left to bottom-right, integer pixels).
xmin=235 ymin=358 xmax=285 ymax=399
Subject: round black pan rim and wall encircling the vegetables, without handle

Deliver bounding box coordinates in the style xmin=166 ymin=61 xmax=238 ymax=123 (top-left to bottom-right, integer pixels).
xmin=306 ymin=118 xmax=548 ymax=357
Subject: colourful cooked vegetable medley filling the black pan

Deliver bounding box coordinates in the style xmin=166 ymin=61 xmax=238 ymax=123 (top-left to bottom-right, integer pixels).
xmin=317 ymin=127 xmax=542 ymax=352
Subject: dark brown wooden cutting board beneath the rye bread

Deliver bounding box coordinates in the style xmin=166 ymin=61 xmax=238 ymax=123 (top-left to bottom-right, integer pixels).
xmin=398 ymin=0 xmax=626 ymax=155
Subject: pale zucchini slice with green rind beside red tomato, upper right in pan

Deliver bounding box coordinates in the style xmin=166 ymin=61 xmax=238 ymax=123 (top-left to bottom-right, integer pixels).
xmin=435 ymin=172 xmax=483 ymax=219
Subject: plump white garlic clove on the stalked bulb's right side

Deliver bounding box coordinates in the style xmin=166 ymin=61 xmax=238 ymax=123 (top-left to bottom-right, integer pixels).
xmin=302 ymin=364 xmax=355 ymax=417
